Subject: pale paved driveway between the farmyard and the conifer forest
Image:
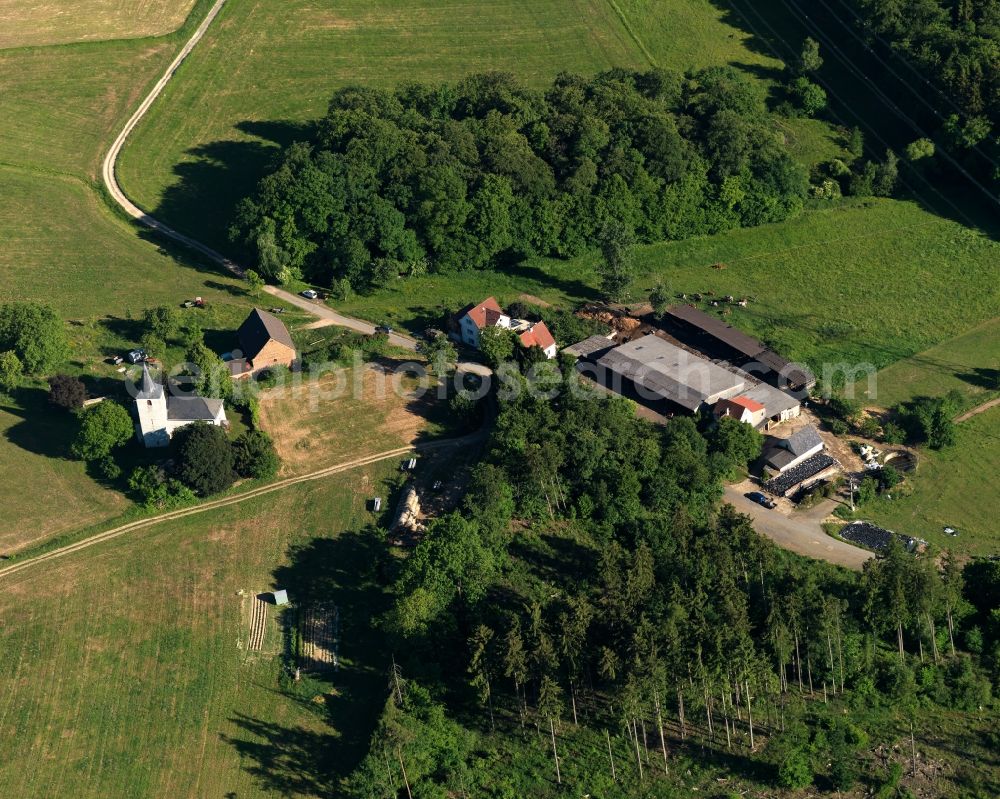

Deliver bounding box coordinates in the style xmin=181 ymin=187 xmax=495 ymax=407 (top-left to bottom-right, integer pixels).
xmin=725 ymin=486 xmax=872 ymax=571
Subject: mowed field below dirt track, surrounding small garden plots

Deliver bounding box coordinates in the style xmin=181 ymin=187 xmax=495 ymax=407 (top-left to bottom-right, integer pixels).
xmin=0 ymin=460 xmax=398 ymax=799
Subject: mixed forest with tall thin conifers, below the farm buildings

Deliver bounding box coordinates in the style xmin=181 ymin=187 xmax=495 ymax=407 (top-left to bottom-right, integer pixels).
xmin=349 ymin=368 xmax=1000 ymax=797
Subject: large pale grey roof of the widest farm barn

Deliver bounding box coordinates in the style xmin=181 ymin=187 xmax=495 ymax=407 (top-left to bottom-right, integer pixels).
xmin=597 ymin=335 xmax=746 ymax=411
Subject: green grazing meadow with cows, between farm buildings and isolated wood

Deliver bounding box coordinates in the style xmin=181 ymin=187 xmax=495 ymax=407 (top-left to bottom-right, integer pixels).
xmin=335 ymin=199 xmax=1000 ymax=373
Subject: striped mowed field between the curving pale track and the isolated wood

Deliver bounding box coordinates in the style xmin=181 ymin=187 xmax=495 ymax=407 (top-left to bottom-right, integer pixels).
xmin=119 ymin=0 xmax=780 ymax=248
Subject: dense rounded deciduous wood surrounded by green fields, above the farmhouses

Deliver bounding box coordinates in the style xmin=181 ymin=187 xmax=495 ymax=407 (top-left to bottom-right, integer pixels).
xmin=232 ymin=67 xmax=807 ymax=290
